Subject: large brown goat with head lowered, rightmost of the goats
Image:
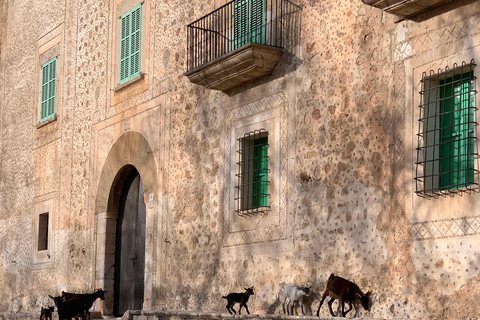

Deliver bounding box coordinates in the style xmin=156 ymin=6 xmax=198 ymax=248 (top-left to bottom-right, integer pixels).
xmin=317 ymin=273 xmax=373 ymax=317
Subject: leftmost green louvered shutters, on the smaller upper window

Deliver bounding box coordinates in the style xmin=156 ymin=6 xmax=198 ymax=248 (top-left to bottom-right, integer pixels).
xmin=40 ymin=58 xmax=57 ymax=122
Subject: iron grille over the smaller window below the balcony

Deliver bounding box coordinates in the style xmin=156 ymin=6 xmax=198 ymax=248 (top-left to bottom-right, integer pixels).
xmin=235 ymin=129 xmax=270 ymax=216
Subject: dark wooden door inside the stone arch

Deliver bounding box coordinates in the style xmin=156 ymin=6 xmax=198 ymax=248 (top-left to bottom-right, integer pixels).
xmin=114 ymin=170 xmax=146 ymax=316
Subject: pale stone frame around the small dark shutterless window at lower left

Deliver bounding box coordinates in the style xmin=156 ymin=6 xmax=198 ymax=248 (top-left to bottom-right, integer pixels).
xmin=32 ymin=199 xmax=55 ymax=268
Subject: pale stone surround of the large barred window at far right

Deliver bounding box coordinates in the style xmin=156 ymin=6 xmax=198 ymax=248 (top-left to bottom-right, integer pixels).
xmin=406 ymin=48 xmax=480 ymax=226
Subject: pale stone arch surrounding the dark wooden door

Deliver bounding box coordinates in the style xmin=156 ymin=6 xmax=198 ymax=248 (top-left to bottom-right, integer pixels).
xmin=95 ymin=131 xmax=159 ymax=315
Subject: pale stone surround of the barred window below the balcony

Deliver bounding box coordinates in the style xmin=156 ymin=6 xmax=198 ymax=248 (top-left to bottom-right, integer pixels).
xmin=223 ymin=93 xmax=288 ymax=247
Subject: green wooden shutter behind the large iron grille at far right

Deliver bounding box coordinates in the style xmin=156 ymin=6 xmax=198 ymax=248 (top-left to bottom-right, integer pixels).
xmin=439 ymin=72 xmax=474 ymax=190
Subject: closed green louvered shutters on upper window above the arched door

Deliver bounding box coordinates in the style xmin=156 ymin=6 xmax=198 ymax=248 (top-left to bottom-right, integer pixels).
xmin=120 ymin=4 xmax=142 ymax=84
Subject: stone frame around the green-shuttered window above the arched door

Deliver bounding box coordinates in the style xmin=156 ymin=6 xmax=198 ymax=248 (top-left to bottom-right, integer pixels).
xmin=112 ymin=0 xmax=148 ymax=92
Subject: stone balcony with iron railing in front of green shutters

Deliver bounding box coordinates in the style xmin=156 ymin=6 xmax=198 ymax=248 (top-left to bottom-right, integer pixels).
xmin=185 ymin=0 xmax=300 ymax=91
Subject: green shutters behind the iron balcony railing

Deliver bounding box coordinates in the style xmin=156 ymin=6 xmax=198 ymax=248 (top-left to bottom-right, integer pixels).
xmin=233 ymin=0 xmax=266 ymax=49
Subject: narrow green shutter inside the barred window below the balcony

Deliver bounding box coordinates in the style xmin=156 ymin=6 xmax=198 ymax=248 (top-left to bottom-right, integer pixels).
xmin=252 ymin=137 xmax=268 ymax=208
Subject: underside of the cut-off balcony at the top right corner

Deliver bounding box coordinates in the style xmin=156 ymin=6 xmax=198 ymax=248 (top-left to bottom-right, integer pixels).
xmin=362 ymin=0 xmax=453 ymax=19
